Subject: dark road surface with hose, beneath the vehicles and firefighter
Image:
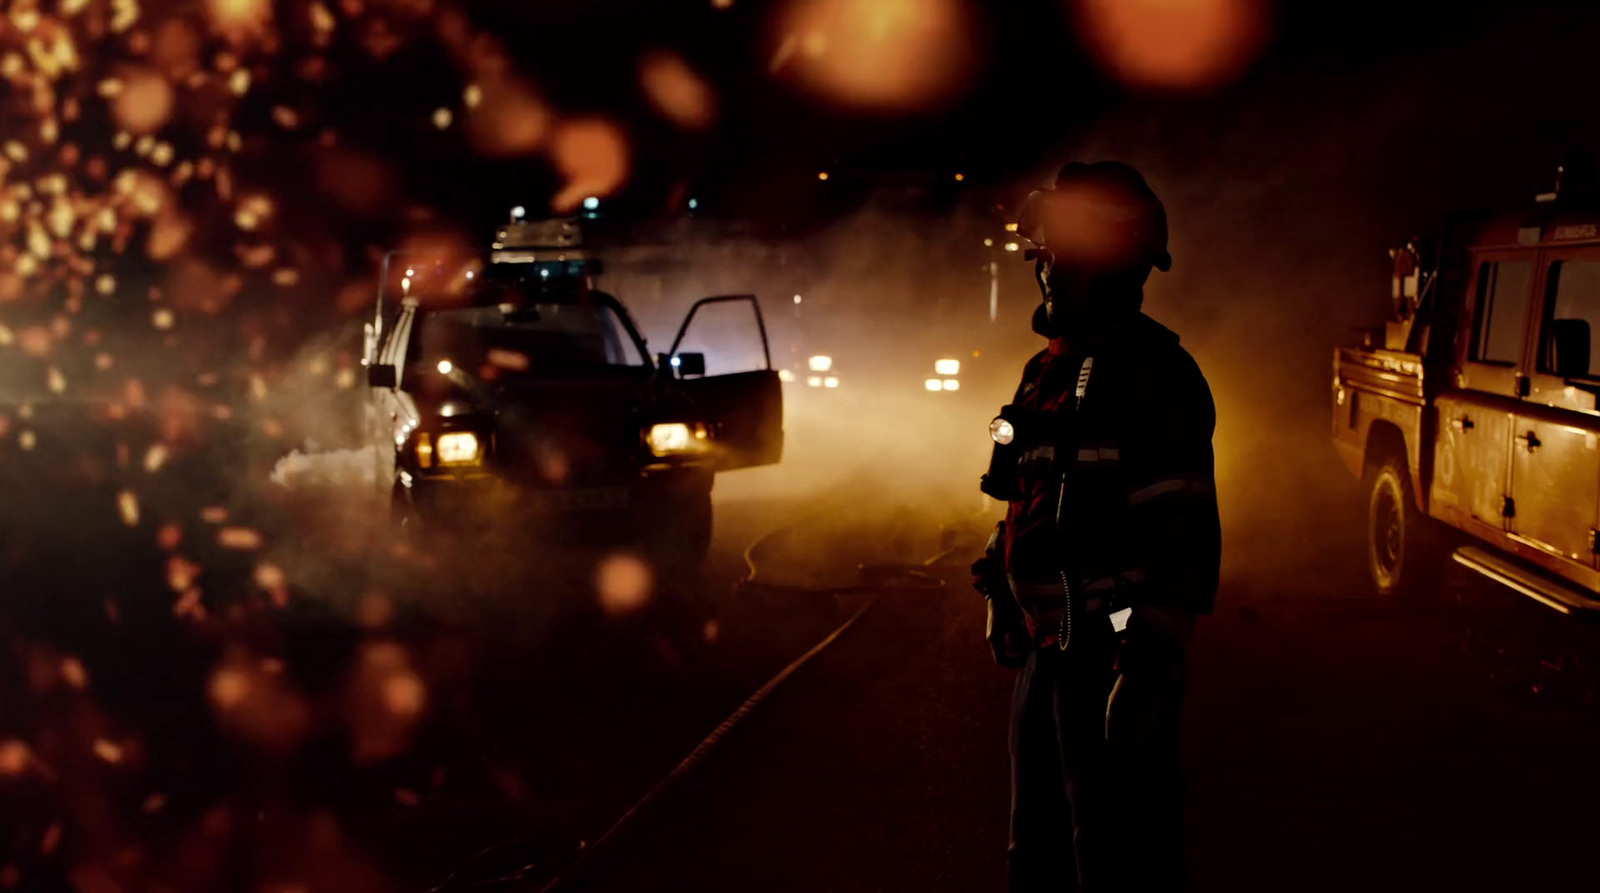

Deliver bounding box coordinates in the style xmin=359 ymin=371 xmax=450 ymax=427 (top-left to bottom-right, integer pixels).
xmin=9 ymin=419 xmax=1600 ymax=893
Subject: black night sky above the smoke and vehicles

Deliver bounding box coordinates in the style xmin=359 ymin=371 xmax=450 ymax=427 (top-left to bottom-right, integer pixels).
xmin=363 ymin=0 xmax=1597 ymax=232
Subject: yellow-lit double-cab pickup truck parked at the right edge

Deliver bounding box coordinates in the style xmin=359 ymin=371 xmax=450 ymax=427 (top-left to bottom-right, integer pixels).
xmin=1333 ymin=164 xmax=1600 ymax=613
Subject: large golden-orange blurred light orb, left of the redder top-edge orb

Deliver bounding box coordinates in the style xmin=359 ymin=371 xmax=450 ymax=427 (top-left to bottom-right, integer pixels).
xmin=770 ymin=0 xmax=974 ymax=110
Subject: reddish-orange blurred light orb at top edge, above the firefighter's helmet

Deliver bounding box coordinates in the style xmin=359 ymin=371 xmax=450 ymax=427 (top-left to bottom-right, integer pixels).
xmin=1074 ymin=0 xmax=1269 ymax=91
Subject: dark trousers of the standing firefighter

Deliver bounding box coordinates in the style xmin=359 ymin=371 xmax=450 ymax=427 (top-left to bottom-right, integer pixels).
xmin=1006 ymin=618 xmax=1187 ymax=893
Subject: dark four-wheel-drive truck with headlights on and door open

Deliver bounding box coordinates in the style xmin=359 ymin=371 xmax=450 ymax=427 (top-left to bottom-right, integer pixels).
xmin=366 ymin=221 xmax=784 ymax=563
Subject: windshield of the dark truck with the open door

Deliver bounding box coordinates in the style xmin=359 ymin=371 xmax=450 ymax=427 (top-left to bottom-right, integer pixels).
xmin=410 ymin=304 xmax=645 ymax=379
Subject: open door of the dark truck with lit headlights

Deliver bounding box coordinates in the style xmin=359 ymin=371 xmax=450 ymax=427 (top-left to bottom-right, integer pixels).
xmin=664 ymin=294 xmax=784 ymax=471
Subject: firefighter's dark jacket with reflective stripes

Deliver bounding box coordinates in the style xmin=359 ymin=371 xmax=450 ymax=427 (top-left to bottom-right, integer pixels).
xmin=1003 ymin=314 xmax=1221 ymax=637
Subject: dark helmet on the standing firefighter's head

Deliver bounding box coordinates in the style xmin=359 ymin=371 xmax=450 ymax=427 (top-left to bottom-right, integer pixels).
xmin=1018 ymin=162 xmax=1173 ymax=272
